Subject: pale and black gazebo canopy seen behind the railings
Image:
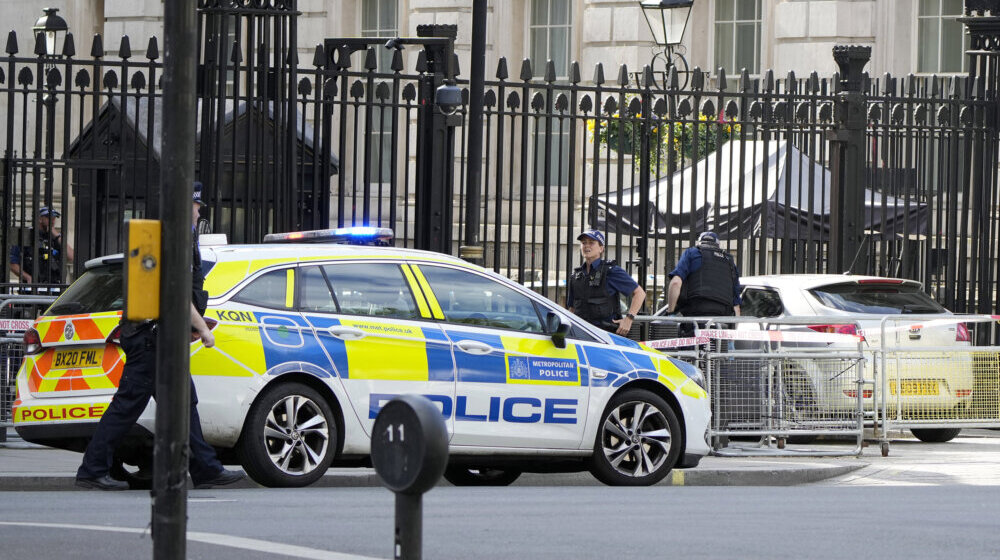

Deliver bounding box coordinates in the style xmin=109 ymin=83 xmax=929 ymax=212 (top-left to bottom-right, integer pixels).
xmin=589 ymin=141 xmax=930 ymax=241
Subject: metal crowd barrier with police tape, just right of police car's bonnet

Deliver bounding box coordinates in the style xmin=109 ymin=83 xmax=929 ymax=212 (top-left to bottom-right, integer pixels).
xmin=640 ymin=317 xmax=874 ymax=456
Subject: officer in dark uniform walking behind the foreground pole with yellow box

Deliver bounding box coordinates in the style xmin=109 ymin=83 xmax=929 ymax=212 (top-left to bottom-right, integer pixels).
xmin=76 ymin=183 xmax=244 ymax=490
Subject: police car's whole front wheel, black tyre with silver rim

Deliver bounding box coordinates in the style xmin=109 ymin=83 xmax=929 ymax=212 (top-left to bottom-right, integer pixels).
xmin=590 ymin=389 xmax=681 ymax=486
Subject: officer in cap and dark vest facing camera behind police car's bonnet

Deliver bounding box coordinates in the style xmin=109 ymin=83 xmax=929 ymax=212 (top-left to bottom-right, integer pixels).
xmin=566 ymin=229 xmax=646 ymax=336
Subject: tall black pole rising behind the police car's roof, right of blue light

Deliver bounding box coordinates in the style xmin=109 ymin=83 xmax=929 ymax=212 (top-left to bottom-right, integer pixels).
xmin=459 ymin=0 xmax=486 ymax=265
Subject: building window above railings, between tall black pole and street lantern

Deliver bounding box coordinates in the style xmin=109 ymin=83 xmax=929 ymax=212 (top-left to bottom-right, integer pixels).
xmin=528 ymin=0 xmax=573 ymax=78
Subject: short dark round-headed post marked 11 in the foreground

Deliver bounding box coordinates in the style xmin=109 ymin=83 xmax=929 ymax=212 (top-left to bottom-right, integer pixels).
xmin=372 ymin=395 xmax=448 ymax=560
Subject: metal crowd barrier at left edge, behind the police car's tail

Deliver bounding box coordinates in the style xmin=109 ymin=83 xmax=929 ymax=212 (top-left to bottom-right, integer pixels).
xmin=0 ymin=294 xmax=56 ymax=441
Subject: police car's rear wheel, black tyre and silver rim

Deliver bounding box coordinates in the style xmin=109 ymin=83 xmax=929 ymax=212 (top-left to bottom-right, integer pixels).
xmin=237 ymin=383 xmax=337 ymax=487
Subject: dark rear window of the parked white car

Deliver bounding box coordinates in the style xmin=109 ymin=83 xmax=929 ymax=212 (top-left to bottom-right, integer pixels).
xmin=809 ymin=282 xmax=947 ymax=315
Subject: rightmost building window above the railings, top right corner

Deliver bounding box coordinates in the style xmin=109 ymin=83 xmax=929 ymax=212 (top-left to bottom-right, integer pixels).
xmin=917 ymin=0 xmax=969 ymax=74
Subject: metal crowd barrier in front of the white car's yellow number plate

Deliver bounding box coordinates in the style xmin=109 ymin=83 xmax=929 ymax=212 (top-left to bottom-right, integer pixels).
xmin=866 ymin=315 xmax=1000 ymax=454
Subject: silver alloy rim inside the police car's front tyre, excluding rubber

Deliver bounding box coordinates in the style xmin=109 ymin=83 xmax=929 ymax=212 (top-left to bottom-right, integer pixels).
xmin=601 ymin=401 xmax=672 ymax=478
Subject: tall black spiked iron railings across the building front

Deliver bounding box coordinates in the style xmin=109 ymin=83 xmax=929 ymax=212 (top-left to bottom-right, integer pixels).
xmin=0 ymin=10 xmax=1000 ymax=320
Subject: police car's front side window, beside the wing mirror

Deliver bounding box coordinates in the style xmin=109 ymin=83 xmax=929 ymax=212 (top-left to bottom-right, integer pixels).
xmin=420 ymin=264 xmax=544 ymax=333
